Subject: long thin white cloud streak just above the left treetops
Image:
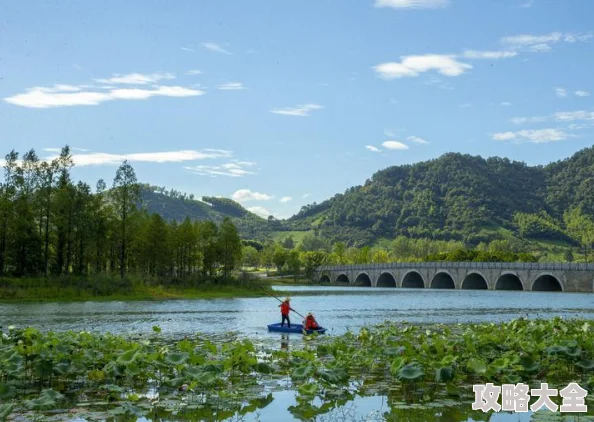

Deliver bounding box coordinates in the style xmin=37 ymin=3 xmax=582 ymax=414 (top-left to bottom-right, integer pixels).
xmin=41 ymin=149 xmax=232 ymax=167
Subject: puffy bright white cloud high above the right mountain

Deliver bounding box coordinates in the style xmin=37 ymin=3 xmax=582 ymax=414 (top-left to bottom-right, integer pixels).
xmin=373 ymin=54 xmax=472 ymax=79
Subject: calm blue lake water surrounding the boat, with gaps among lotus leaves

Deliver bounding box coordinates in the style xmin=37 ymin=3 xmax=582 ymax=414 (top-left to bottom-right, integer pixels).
xmin=0 ymin=286 xmax=594 ymax=422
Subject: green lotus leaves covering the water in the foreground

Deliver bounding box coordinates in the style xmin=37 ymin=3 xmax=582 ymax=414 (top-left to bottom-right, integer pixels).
xmin=0 ymin=318 xmax=594 ymax=421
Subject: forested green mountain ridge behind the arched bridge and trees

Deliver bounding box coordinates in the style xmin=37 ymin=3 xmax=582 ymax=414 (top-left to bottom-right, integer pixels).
xmin=142 ymin=148 xmax=594 ymax=246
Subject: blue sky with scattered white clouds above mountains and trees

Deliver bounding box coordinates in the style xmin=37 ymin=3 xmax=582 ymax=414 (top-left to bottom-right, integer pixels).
xmin=0 ymin=0 xmax=594 ymax=218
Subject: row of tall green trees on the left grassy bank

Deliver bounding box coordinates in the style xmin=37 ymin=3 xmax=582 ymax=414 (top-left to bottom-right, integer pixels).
xmin=0 ymin=146 xmax=242 ymax=279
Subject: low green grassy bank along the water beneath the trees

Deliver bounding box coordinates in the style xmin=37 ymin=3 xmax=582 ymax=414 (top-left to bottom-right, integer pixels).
xmin=0 ymin=276 xmax=269 ymax=302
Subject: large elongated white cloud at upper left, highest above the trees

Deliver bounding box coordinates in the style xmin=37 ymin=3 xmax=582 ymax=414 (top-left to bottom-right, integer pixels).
xmin=4 ymin=73 xmax=204 ymax=108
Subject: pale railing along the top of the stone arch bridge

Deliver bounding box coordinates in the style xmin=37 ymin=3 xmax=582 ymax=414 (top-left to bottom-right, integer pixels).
xmin=317 ymin=261 xmax=594 ymax=272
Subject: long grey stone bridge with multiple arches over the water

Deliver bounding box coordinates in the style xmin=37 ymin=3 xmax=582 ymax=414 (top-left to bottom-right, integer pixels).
xmin=314 ymin=262 xmax=594 ymax=292
